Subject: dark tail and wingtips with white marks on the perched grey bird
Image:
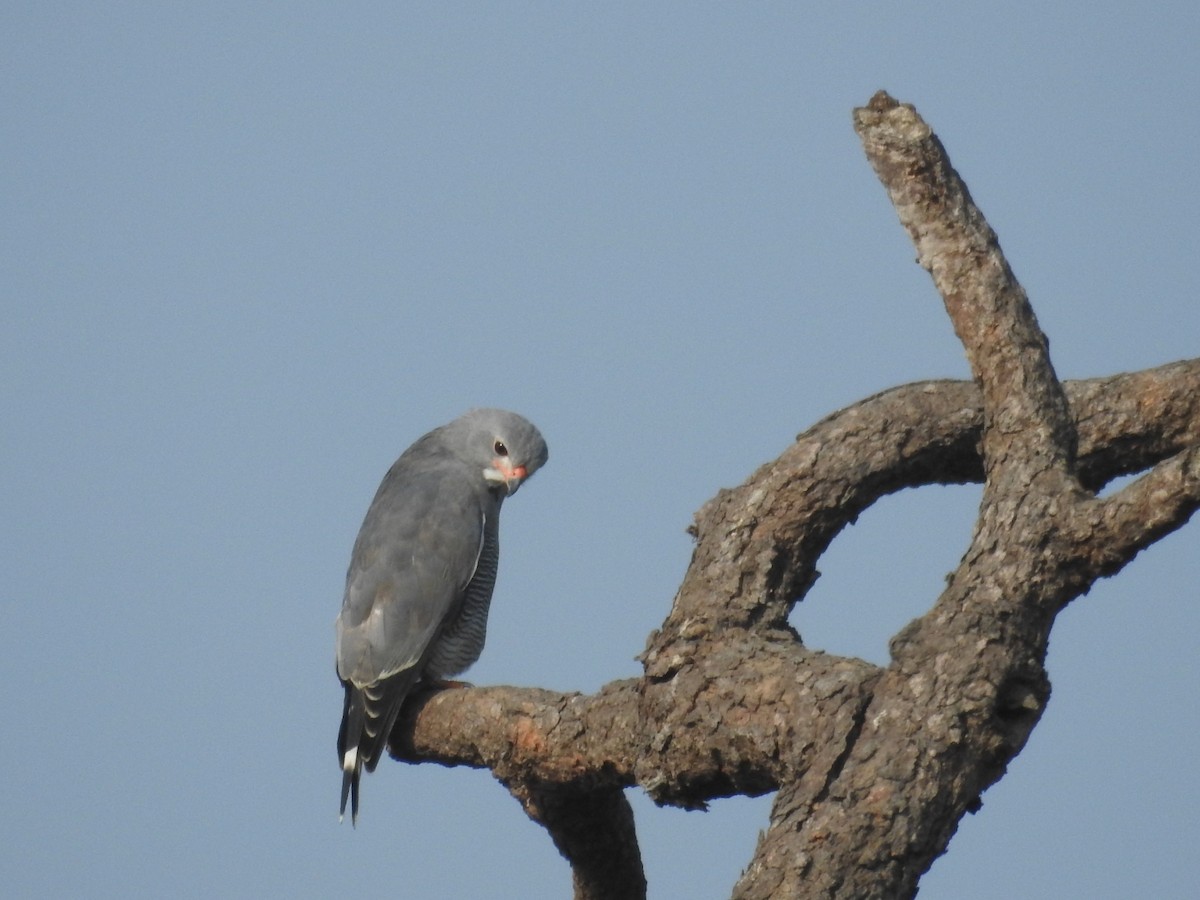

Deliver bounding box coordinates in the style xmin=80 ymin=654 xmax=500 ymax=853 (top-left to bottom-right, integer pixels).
xmin=337 ymin=670 xmax=416 ymax=824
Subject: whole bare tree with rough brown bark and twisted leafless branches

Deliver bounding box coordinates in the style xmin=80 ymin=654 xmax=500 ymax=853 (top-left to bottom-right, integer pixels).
xmin=391 ymin=92 xmax=1200 ymax=899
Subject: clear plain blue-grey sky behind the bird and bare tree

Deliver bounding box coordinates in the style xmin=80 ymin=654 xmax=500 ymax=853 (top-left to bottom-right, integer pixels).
xmin=0 ymin=1 xmax=1200 ymax=900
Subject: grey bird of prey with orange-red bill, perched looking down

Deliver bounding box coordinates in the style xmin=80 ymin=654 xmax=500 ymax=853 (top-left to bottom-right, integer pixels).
xmin=336 ymin=409 xmax=550 ymax=826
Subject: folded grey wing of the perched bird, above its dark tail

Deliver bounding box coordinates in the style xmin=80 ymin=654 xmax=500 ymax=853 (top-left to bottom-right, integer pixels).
xmin=337 ymin=457 xmax=485 ymax=685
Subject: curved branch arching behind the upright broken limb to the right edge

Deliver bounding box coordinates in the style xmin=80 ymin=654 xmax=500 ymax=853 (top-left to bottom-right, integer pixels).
xmin=652 ymin=360 xmax=1200 ymax=646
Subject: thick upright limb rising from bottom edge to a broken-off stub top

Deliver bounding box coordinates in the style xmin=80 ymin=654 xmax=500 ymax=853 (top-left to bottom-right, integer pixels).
xmin=737 ymin=92 xmax=1187 ymax=898
